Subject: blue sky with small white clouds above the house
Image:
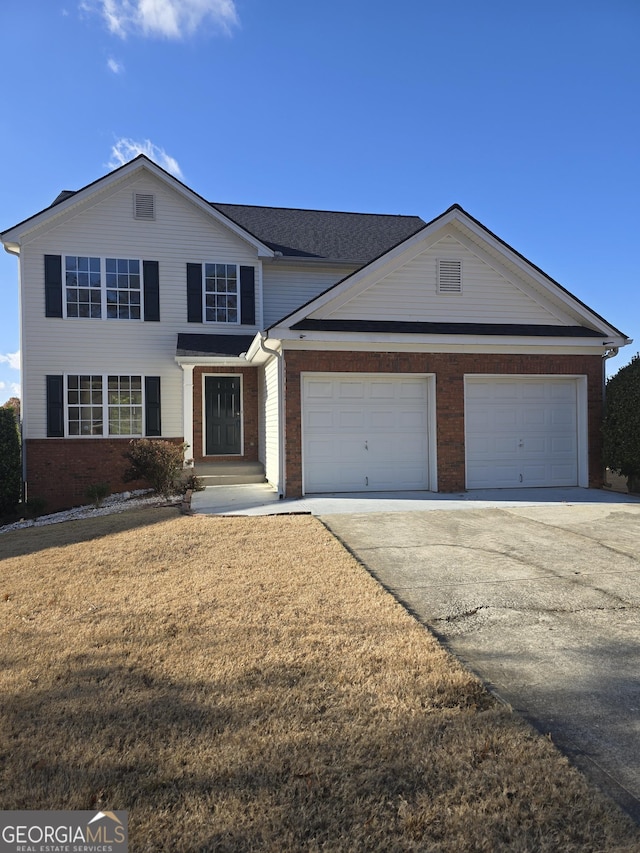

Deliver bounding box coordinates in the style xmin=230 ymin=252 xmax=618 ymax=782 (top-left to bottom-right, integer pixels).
xmin=0 ymin=0 xmax=640 ymax=402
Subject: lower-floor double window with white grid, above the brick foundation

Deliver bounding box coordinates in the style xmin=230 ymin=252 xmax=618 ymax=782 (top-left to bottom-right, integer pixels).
xmin=67 ymin=375 xmax=143 ymax=437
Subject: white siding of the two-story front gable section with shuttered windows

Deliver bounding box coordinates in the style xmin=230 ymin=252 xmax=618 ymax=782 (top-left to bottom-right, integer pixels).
xmin=21 ymin=176 xmax=261 ymax=438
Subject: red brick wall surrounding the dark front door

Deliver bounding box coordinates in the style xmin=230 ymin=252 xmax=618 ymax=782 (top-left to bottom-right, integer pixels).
xmin=187 ymin=367 xmax=258 ymax=464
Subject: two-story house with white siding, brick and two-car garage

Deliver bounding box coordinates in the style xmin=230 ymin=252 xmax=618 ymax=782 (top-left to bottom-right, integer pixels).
xmin=1 ymin=156 xmax=630 ymax=510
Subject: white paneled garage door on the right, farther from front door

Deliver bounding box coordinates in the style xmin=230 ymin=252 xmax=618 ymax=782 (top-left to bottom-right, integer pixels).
xmin=465 ymin=377 xmax=578 ymax=489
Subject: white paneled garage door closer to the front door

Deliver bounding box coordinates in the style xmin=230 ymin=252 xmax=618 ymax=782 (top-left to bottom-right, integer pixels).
xmin=302 ymin=374 xmax=429 ymax=493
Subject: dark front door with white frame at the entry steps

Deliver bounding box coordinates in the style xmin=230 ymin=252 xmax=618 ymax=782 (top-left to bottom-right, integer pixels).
xmin=204 ymin=376 xmax=242 ymax=456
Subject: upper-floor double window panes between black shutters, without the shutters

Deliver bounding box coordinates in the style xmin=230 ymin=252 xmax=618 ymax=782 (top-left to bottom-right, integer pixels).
xmin=64 ymin=255 xmax=148 ymax=320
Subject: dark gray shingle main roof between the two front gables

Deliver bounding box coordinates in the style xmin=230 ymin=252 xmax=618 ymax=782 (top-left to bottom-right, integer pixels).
xmin=211 ymin=202 xmax=426 ymax=264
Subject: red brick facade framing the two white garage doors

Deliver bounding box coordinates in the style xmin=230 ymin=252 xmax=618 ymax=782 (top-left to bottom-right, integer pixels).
xmin=285 ymin=350 xmax=603 ymax=497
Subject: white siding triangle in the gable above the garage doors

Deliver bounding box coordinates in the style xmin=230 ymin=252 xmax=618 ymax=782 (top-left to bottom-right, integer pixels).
xmin=318 ymin=235 xmax=575 ymax=325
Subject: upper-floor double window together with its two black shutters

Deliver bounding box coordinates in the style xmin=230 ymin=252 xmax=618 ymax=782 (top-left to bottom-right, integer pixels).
xmin=44 ymin=255 xmax=160 ymax=321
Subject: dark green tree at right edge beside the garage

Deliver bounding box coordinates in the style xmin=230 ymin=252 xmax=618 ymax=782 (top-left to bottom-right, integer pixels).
xmin=602 ymin=353 xmax=640 ymax=492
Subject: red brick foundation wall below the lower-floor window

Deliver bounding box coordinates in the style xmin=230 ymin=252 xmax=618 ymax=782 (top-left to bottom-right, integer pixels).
xmin=25 ymin=438 xmax=182 ymax=512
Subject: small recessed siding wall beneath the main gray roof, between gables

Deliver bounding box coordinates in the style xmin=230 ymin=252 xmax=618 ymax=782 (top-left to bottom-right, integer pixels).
xmin=263 ymin=261 xmax=356 ymax=328
